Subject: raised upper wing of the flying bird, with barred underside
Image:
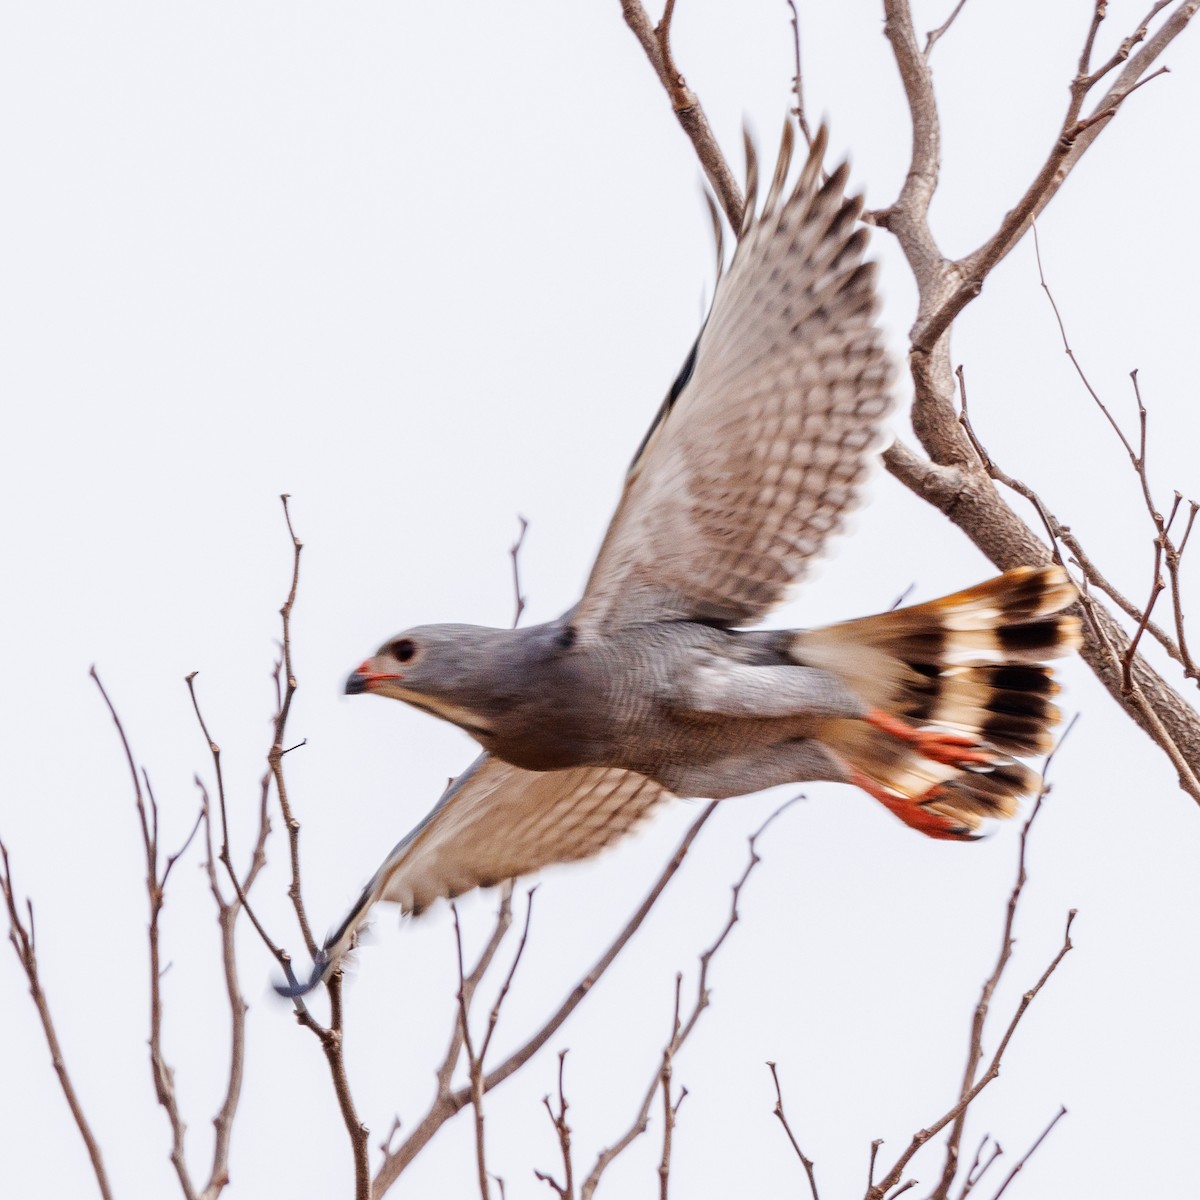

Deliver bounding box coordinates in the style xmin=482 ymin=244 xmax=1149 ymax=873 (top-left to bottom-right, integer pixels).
xmin=572 ymin=125 xmax=890 ymax=636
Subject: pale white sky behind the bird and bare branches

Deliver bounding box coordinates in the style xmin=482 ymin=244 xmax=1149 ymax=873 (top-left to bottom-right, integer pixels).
xmin=0 ymin=0 xmax=1200 ymax=1198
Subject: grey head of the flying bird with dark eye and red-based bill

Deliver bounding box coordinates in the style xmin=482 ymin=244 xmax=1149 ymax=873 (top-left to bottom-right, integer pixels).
xmin=346 ymin=625 xmax=509 ymax=737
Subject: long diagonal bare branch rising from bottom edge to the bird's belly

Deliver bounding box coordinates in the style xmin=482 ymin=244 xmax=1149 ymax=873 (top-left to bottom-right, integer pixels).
xmin=372 ymin=803 xmax=716 ymax=1198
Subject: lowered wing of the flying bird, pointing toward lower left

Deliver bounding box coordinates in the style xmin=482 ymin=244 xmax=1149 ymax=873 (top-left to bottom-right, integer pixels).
xmin=276 ymin=754 xmax=671 ymax=996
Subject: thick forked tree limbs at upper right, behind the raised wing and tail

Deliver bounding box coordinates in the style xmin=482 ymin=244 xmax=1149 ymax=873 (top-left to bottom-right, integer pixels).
xmin=622 ymin=0 xmax=1200 ymax=816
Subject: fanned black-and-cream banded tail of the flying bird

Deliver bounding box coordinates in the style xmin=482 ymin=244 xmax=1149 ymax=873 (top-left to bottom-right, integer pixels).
xmin=792 ymin=566 xmax=1081 ymax=839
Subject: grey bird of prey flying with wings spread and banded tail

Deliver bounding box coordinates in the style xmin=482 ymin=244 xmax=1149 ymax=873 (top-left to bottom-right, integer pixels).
xmin=278 ymin=122 xmax=1080 ymax=996
